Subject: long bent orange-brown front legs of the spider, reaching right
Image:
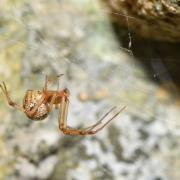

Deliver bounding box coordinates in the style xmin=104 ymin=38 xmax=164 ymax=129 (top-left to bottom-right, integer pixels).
xmin=59 ymin=97 xmax=125 ymax=135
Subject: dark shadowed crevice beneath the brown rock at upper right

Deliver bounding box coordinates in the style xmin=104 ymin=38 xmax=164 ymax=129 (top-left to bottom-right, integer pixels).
xmin=113 ymin=23 xmax=180 ymax=95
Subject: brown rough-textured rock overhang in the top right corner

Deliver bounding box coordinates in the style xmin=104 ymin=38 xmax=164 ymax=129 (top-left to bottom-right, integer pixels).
xmin=103 ymin=0 xmax=180 ymax=42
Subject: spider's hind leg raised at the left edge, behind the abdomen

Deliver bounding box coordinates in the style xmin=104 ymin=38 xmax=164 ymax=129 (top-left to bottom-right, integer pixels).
xmin=0 ymin=81 xmax=24 ymax=111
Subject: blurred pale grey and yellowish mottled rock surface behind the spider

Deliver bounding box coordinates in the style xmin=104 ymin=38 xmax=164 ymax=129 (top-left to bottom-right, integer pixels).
xmin=0 ymin=0 xmax=180 ymax=180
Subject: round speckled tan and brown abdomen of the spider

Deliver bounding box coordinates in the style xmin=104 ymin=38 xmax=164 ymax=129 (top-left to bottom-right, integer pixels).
xmin=23 ymin=90 xmax=49 ymax=121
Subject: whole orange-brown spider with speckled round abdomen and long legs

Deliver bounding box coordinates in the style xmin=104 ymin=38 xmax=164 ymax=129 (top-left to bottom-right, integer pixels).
xmin=0 ymin=74 xmax=125 ymax=135
